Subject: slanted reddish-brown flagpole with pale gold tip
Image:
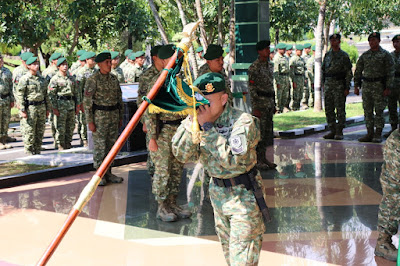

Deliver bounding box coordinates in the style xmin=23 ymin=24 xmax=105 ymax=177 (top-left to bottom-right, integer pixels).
xmin=37 ymin=22 xmax=199 ymax=265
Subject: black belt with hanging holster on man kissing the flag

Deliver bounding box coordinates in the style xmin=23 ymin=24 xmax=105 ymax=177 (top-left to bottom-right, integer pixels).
xmin=213 ymin=167 xmax=271 ymax=222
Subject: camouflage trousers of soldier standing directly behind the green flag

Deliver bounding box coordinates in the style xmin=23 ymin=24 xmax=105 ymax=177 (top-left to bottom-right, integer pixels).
xmin=150 ymin=124 xmax=184 ymax=201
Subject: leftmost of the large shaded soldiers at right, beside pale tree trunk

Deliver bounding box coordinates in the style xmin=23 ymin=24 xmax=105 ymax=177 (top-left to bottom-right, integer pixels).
xmin=322 ymin=34 xmax=353 ymax=140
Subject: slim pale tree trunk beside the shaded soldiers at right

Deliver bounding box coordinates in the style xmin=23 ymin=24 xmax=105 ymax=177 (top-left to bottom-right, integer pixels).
xmin=314 ymin=0 xmax=326 ymax=112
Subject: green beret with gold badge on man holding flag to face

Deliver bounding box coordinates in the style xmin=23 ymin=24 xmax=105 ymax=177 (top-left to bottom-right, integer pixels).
xmin=193 ymin=72 xmax=225 ymax=95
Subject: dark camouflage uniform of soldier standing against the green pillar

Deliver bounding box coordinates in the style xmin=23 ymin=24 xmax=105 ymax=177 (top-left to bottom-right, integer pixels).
xmin=247 ymin=58 xmax=275 ymax=150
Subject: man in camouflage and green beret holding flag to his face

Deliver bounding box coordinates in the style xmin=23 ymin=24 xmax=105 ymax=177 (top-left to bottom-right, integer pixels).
xmin=172 ymin=73 xmax=268 ymax=265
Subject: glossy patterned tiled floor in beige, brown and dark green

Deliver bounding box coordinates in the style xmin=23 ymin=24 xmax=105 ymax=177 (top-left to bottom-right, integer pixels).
xmin=0 ymin=126 xmax=399 ymax=265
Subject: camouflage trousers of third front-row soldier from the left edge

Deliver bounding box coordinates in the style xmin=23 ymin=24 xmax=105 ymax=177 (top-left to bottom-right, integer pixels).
xmin=53 ymin=109 xmax=75 ymax=148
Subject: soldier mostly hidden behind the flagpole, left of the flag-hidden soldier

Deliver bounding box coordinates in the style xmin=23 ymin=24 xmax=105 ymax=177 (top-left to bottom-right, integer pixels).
xmin=136 ymin=45 xmax=162 ymax=177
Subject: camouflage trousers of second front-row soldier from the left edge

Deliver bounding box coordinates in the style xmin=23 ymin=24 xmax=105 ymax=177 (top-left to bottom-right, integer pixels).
xmin=21 ymin=104 xmax=46 ymax=154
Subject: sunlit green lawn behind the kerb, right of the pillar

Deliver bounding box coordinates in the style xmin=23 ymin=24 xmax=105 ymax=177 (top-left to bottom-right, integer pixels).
xmin=274 ymin=103 xmax=364 ymax=131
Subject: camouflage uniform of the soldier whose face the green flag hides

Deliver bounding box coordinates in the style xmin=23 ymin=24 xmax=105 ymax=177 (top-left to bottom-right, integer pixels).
xmin=145 ymin=73 xmax=184 ymax=202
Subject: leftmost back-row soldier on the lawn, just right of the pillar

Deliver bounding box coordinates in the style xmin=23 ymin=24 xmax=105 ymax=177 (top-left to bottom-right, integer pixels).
xmin=273 ymin=43 xmax=290 ymax=113
